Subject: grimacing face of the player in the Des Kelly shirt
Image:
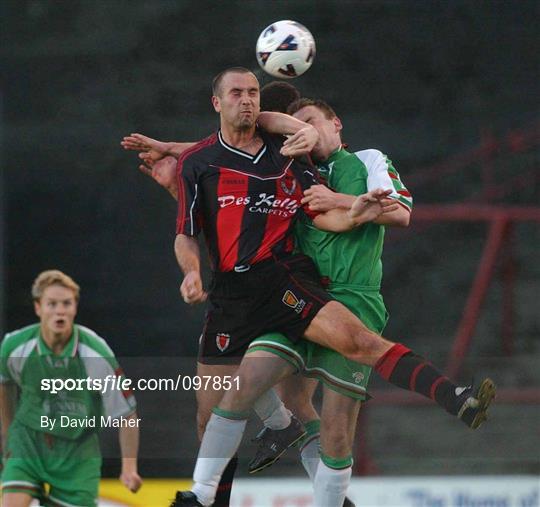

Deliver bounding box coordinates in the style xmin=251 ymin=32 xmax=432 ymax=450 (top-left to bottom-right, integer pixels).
xmin=212 ymin=72 xmax=260 ymax=130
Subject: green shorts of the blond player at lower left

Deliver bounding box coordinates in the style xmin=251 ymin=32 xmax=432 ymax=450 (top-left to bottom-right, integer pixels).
xmin=2 ymin=421 xmax=101 ymax=507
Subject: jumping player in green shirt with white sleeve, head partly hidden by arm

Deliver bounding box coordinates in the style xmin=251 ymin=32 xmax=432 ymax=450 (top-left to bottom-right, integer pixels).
xmin=240 ymin=99 xmax=412 ymax=505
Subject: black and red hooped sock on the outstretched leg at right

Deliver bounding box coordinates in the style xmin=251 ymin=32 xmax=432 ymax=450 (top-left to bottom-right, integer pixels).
xmin=375 ymin=343 xmax=459 ymax=415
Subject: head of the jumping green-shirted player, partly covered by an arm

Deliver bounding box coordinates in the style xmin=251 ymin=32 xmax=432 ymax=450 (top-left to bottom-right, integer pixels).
xmin=287 ymin=98 xmax=343 ymax=160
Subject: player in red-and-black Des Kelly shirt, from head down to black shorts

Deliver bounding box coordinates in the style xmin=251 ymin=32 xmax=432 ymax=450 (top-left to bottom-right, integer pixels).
xmin=175 ymin=68 xmax=393 ymax=364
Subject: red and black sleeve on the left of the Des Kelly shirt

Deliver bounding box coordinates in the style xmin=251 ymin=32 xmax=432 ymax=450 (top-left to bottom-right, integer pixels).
xmin=176 ymin=152 xmax=200 ymax=236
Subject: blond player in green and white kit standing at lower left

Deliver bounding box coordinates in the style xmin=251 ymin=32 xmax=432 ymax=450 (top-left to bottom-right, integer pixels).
xmin=0 ymin=270 xmax=142 ymax=507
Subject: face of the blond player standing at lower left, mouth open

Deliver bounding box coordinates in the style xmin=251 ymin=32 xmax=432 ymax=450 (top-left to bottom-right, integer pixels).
xmin=34 ymin=285 xmax=77 ymax=337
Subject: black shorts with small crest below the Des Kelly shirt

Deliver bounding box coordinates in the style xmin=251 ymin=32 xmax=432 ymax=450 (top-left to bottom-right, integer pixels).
xmin=199 ymin=254 xmax=332 ymax=364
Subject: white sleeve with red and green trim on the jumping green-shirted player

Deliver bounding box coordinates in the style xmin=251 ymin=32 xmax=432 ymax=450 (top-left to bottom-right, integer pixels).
xmin=355 ymin=150 xmax=413 ymax=211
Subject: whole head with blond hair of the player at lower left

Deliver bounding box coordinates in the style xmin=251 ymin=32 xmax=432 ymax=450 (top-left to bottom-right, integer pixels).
xmin=32 ymin=269 xmax=80 ymax=337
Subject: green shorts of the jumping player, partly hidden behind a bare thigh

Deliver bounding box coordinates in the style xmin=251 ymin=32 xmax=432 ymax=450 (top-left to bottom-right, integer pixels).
xmin=247 ymin=286 xmax=388 ymax=400
